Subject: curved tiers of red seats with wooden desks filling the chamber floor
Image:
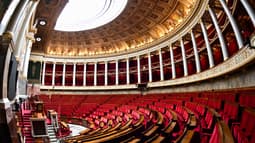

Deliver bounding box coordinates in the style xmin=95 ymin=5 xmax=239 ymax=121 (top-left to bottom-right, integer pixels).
xmin=39 ymin=91 xmax=255 ymax=143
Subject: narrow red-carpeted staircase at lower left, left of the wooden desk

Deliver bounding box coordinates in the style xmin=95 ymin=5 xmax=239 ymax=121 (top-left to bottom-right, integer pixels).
xmin=22 ymin=110 xmax=34 ymax=143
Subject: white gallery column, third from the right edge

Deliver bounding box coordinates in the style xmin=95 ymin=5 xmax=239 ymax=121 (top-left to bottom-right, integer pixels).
xmin=208 ymin=6 xmax=228 ymax=60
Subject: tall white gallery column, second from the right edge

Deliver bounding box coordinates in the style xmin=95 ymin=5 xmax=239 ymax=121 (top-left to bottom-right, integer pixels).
xmin=219 ymin=0 xmax=244 ymax=49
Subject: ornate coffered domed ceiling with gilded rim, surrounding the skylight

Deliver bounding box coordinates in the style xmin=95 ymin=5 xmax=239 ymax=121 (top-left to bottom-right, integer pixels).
xmin=32 ymin=0 xmax=199 ymax=57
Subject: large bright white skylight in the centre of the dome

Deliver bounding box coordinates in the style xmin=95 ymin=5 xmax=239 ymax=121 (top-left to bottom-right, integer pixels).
xmin=55 ymin=0 xmax=128 ymax=31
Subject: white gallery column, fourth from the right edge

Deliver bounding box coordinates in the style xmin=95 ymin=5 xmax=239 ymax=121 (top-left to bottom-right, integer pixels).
xmin=200 ymin=20 xmax=214 ymax=68
